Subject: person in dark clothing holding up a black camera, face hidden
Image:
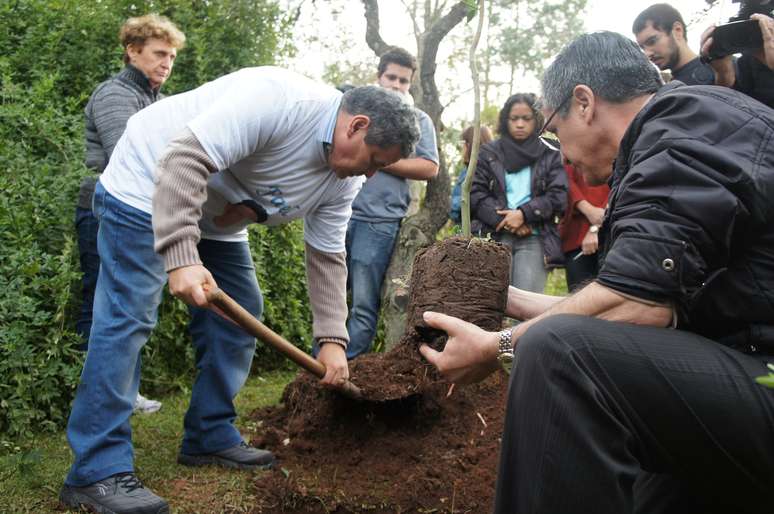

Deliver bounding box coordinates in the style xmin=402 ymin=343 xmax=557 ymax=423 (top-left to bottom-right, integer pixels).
xmin=701 ymin=12 xmax=774 ymax=108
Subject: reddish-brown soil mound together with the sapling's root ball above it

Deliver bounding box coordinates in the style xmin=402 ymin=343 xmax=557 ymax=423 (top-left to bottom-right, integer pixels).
xmin=252 ymin=238 xmax=510 ymax=513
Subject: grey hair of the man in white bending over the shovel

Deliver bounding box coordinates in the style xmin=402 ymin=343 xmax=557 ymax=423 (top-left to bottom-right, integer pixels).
xmin=341 ymin=86 xmax=419 ymax=159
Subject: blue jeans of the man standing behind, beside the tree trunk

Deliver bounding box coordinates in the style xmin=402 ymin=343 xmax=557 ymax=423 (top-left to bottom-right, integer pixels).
xmin=347 ymin=219 xmax=400 ymax=359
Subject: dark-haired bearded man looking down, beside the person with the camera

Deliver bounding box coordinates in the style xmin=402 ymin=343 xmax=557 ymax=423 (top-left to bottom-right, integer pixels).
xmin=632 ymin=4 xmax=715 ymax=86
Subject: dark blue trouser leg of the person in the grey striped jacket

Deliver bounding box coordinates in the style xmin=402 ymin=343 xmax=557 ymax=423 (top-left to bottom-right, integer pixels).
xmin=75 ymin=207 xmax=99 ymax=351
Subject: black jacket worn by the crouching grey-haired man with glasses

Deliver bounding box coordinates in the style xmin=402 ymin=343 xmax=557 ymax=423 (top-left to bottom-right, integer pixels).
xmin=598 ymin=84 xmax=774 ymax=353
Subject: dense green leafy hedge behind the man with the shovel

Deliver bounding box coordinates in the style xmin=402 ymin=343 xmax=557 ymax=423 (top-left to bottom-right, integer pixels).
xmin=0 ymin=0 xmax=304 ymax=435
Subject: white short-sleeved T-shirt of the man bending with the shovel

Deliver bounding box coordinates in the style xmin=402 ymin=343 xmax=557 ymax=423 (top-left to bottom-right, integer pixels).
xmin=101 ymin=67 xmax=363 ymax=252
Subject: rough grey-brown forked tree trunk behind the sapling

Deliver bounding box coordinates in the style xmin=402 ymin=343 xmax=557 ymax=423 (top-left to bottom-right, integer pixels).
xmin=362 ymin=0 xmax=470 ymax=349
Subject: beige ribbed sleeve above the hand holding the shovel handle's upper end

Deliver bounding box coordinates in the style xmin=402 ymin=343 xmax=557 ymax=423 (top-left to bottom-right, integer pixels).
xmin=153 ymin=128 xmax=218 ymax=271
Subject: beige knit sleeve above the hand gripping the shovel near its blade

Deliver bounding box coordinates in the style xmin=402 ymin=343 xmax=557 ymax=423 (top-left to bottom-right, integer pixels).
xmin=305 ymin=243 xmax=349 ymax=347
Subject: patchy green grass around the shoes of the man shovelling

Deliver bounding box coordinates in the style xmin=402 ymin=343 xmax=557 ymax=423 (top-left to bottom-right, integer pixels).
xmin=0 ymin=371 xmax=295 ymax=514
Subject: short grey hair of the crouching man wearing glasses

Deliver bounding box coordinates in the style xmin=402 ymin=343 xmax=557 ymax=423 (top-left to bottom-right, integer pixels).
xmin=543 ymin=31 xmax=663 ymax=117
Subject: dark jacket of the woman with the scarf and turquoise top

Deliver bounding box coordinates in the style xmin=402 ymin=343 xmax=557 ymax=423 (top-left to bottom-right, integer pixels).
xmin=470 ymin=139 xmax=568 ymax=268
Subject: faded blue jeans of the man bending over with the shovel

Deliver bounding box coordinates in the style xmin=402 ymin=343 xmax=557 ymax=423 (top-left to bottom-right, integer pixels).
xmin=65 ymin=183 xmax=262 ymax=486
